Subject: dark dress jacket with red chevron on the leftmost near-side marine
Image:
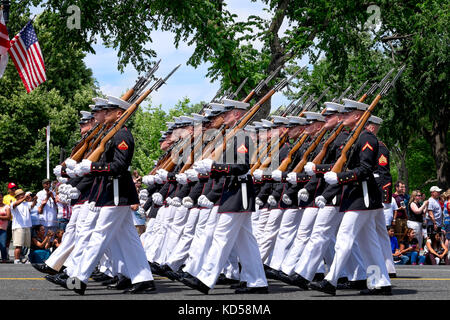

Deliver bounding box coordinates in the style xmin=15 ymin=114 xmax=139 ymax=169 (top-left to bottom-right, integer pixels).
xmin=89 ymin=127 xmax=139 ymax=207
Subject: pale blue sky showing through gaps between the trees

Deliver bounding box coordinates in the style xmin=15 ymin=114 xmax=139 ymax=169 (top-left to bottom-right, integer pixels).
xmin=35 ymin=0 xmax=312 ymax=111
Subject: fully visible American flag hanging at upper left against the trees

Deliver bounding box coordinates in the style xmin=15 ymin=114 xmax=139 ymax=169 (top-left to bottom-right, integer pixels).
xmin=8 ymin=20 xmax=47 ymax=92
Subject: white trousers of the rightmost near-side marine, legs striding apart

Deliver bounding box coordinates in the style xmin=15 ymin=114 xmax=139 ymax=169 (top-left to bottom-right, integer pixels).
xmin=325 ymin=209 xmax=391 ymax=287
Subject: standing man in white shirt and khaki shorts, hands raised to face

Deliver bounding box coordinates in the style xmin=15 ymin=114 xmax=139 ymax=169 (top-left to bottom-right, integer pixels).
xmin=11 ymin=189 xmax=32 ymax=264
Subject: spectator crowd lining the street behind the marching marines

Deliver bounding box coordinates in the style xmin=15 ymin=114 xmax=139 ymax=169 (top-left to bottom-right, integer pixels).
xmin=0 ymin=176 xmax=450 ymax=265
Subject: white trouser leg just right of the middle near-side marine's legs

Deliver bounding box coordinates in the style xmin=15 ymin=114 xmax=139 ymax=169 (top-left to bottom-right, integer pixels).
xmin=259 ymin=209 xmax=284 ymax=264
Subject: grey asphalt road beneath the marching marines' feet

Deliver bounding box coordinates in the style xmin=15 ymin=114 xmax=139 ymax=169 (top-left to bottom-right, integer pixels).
xmin=0 ymin=264 xmax=450 ymax=302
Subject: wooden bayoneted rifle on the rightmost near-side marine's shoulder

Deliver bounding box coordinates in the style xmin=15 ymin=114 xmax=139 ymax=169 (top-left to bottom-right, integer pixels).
xmin=331 ymin=65 xmax=406 ymax=173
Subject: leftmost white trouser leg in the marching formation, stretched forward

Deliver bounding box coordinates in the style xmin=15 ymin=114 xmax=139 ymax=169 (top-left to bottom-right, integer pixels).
xmin=45 ymin=204 xmax=81 ymax=270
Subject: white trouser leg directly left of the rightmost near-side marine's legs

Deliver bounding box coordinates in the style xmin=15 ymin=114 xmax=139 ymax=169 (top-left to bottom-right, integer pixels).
xmin=295 ymin=206 xmax=342 ymax=281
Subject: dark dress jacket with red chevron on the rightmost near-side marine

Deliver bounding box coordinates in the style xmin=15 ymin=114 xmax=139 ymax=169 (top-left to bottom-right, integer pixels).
xmin=337 ymin=130 xmax=383 ymax=212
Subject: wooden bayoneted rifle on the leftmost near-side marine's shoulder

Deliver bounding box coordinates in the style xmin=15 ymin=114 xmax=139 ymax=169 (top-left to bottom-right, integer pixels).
xmin=88 ymin=64 xmax=181 ymax=161
